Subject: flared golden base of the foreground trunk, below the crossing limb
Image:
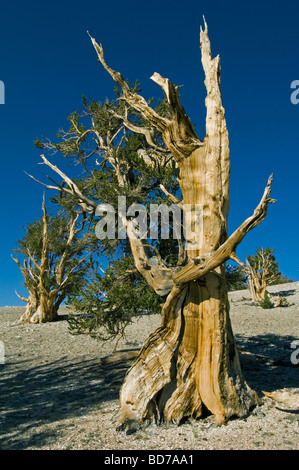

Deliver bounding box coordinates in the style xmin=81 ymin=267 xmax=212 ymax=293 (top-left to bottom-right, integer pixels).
xmin=118 ymin=273 xmax=258 ymax=428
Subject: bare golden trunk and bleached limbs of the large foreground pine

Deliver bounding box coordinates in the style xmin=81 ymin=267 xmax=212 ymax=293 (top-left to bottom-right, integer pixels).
xmin=86 ymin=22 xmax=274 ymax=428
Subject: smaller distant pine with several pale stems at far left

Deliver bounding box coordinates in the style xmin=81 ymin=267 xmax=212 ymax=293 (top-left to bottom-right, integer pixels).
xmin=12 ymin=196 xmax=87 ymax=323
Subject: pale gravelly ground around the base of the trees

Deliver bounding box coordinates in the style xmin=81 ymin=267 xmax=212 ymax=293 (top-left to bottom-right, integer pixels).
xmin=0 ymin=282 xmax=299 ymax=450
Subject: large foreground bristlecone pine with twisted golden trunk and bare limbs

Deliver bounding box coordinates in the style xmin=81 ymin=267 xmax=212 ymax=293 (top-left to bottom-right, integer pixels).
xmin=28 ymin=23 xmax=274 ymax=429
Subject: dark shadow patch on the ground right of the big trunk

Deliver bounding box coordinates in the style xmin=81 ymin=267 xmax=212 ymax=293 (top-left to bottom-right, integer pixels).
xmin=236 ymin=334 xmax=299 ymax=396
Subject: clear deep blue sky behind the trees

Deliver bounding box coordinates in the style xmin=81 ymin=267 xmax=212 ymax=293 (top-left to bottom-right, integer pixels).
xmin=0 ymin=0 xmax=299 ymax=306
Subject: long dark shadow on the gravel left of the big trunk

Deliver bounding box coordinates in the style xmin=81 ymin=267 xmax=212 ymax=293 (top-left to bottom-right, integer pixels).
xmin=0 ymin=351 xmax=137 ymax=450
